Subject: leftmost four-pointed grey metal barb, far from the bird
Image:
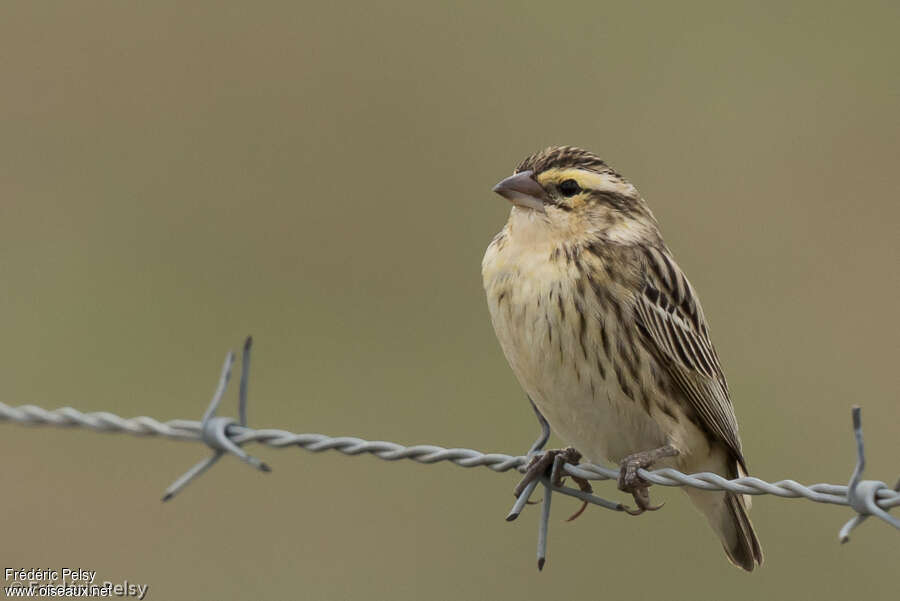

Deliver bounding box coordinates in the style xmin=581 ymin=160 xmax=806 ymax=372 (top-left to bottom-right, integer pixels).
xmin=162 ymin=336 xmax=272 ymax=502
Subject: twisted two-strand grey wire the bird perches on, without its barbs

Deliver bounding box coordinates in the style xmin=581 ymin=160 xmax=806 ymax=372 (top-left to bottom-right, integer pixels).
xmin=0 ymin=402 xmax=900 ymax=510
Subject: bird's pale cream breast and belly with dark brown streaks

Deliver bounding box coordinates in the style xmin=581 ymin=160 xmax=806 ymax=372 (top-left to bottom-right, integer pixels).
xmin=482 ymin=225 xmax=692 ymax=462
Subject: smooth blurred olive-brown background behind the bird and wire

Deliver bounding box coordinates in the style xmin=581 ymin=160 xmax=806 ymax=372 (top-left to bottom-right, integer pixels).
xmin=0 ymin=1 xmax=900 ymax=601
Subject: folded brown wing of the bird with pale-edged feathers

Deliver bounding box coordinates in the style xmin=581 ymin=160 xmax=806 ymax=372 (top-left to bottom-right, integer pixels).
xmin=636 ymin=249 xmax=746 ymax=471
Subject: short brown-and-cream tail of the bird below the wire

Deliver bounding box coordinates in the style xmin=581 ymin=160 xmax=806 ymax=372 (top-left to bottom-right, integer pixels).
xmin=686 ymin=466 xmax=763 ymax=572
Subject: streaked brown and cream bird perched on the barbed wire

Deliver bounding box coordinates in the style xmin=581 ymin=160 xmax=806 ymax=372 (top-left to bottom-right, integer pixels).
xmin=482 ymin=146 xmax=763 ymax=572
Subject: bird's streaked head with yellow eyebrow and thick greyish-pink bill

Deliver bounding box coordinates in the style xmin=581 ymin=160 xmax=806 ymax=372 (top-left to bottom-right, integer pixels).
xmin=494 ymin=146 xmax=659 ymax=244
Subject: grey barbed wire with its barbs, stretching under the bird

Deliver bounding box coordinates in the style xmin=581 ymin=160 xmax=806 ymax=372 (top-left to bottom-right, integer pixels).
xmin=0 ymin=338 xmax=900 ymax=568
